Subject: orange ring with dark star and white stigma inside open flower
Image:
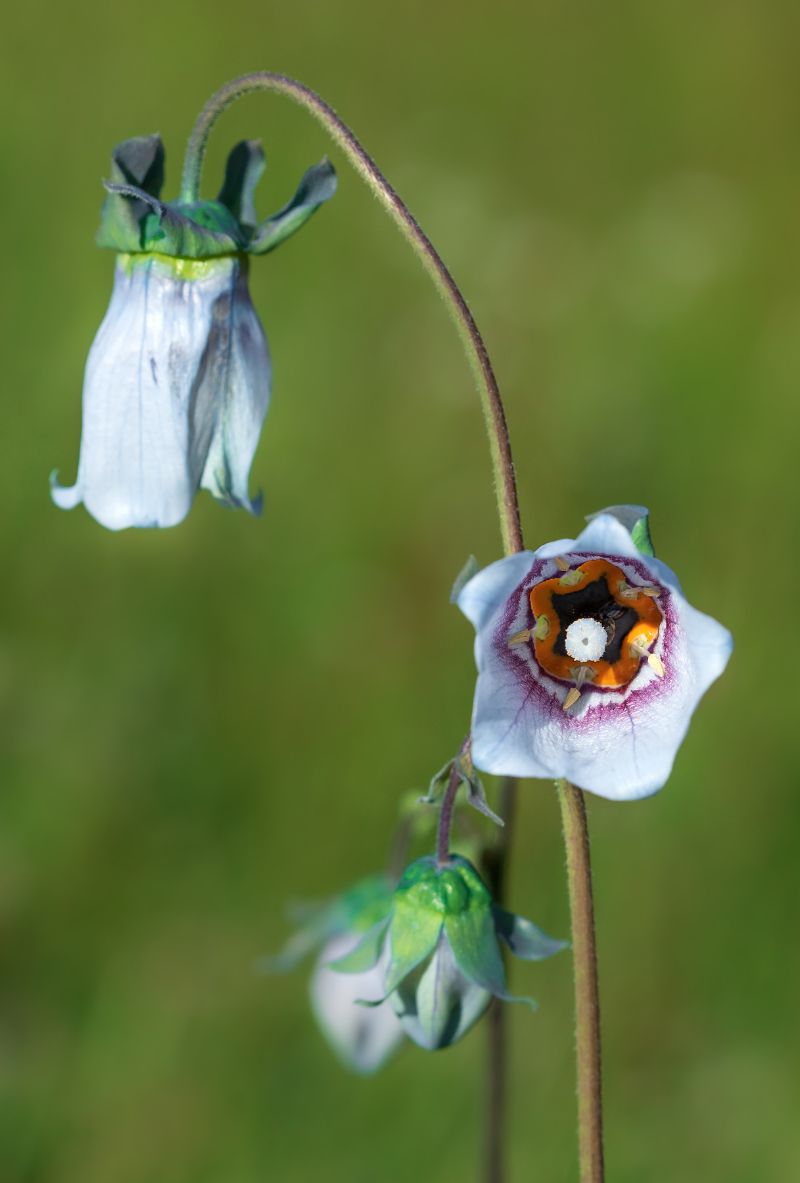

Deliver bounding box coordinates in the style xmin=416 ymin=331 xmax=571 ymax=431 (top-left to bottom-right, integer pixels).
xmin=530 ymin=558 xmax=664 ymax=687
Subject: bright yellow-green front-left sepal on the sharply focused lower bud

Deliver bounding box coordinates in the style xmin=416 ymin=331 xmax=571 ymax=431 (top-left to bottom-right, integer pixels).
xmin=386 ymin=855 xmax=445 ymax=995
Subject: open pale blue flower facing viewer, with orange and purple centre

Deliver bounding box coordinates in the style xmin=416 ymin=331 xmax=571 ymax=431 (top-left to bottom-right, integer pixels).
xmin=457 ymin=505 xmax=733 ymax=801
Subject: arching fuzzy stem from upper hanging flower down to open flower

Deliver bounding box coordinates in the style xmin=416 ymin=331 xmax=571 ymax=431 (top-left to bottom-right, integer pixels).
xmin=181 ymin=73 xmax=523 ymax=555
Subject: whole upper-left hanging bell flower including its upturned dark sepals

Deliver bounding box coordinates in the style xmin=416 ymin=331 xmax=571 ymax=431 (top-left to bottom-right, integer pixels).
xmin=51 ymin=135 xmax=336 ymax=530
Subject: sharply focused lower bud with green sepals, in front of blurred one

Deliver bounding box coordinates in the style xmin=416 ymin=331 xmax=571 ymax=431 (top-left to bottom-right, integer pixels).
xmin=331 ymin=854 xmax=566 ymax=1052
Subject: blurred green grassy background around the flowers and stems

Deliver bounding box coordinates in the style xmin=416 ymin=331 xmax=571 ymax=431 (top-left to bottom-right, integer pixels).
xmin=0 ymin=0 xmax=800 ymax=1183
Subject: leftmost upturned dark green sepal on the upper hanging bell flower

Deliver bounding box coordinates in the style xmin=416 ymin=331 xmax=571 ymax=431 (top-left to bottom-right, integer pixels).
xmin=95 ymin=135 xmax=164 ymax=251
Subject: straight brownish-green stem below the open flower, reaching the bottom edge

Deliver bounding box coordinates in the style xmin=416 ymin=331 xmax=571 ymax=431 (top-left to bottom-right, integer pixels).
xmin=556 ymin=781 xmax=604 ymax=1183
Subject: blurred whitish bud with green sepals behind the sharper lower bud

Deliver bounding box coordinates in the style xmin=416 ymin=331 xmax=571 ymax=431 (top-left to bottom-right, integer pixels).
xmin=262 ymin=875 xmax=404 ymax=1075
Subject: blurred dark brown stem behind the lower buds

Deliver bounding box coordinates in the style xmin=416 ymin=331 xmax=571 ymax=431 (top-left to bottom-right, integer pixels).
xmin=483 ymin=776 xmax=517 ymax=1183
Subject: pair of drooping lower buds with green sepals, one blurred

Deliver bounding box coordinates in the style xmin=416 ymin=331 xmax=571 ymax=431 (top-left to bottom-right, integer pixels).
xmin=269 ymin=854 xmax=566 ymax=1072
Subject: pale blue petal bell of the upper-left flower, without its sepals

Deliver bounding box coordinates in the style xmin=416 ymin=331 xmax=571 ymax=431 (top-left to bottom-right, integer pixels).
xmin=51 ymin=253 xmax=271 ymax=530
